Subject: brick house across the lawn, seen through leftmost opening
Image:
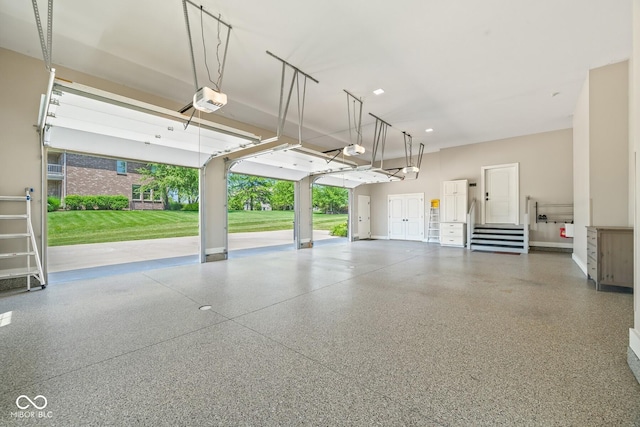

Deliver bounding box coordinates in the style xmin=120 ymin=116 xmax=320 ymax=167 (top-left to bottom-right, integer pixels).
xmin=47 ymin=153 xmax=164 ymax=210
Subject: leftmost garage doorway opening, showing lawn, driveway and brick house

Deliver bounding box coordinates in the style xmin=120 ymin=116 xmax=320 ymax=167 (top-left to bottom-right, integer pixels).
xmin=47 ymin=150 xmax=199 ymax=273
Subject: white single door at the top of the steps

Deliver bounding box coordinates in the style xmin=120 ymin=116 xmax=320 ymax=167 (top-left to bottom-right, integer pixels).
xmin=483 ymin=164 xmax=519 ymax=224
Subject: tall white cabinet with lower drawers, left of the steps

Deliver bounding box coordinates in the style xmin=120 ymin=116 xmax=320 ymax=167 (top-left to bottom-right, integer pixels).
xmin=440 ymin=179 xmax=469 ymax=247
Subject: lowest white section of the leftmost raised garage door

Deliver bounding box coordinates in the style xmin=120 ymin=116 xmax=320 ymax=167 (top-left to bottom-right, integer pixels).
xmin=47 ymin=127 xmax=210 ymax=168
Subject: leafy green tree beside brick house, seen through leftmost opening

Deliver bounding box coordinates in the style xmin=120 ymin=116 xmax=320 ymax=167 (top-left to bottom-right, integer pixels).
xmin=138 ymin=163 xmax=200 ymax=208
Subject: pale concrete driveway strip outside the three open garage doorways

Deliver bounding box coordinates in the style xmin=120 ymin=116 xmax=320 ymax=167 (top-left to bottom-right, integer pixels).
xmin=47 ymin=230 xmax=335 ymax=273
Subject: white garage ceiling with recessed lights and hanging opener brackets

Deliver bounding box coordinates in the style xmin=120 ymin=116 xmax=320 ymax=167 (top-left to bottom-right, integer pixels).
xmin=0 ymin=0 xmax=631 ymax=158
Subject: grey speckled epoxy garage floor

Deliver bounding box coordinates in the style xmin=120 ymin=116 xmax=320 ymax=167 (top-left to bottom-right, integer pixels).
xmin=0 ymin=241 xmax=640 ymax=426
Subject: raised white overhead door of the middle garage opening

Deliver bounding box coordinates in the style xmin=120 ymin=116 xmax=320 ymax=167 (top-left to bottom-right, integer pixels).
xmin=230 ymin=148 xmax=356 ymax=181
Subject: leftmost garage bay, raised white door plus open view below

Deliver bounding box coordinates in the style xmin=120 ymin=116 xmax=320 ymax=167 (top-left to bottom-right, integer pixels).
xmin=40 ymin=80 xmax=261 ymax=280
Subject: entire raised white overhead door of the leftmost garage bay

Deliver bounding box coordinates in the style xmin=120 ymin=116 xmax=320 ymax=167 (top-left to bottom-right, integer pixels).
xmin=45 ymin=82 xmax=260 ymax=167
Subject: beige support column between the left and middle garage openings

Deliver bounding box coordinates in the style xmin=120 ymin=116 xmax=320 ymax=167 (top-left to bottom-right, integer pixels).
xmin=200 ymin=157 xmax=228 ymax=262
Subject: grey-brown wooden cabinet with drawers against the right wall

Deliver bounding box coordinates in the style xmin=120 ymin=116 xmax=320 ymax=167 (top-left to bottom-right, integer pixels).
xmin=587 ymin=226 xmax=633 ymax=291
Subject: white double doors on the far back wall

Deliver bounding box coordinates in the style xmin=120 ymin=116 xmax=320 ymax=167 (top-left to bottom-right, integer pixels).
xmin=389 ymin=193 xmax=424 ymax=241
